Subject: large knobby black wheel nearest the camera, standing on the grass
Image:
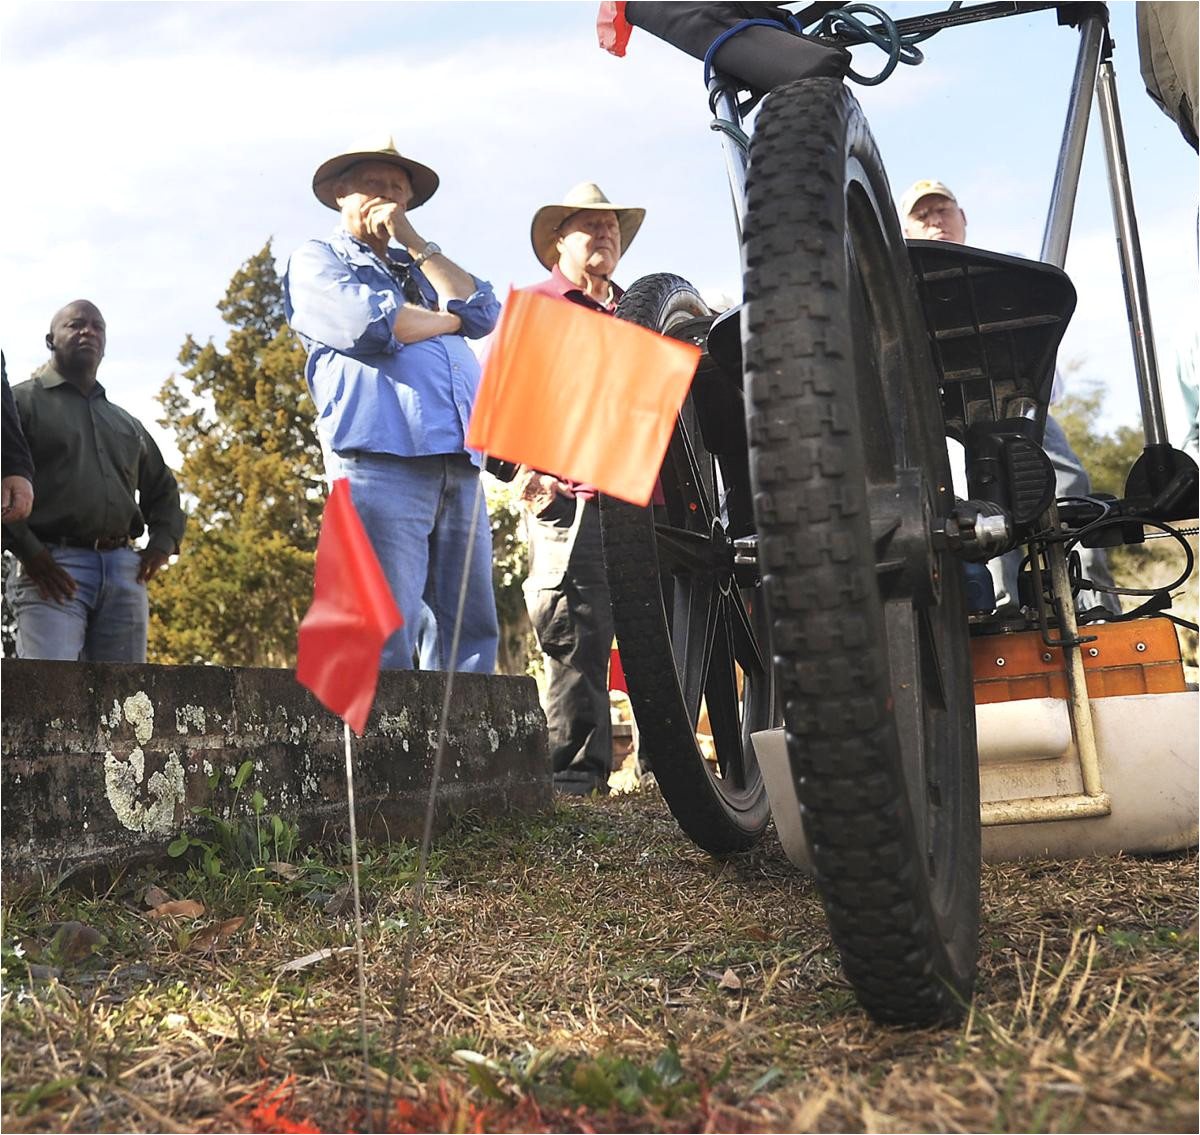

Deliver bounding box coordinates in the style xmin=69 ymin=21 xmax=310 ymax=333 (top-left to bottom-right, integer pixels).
xmin=744 ymin=79 xmax=979 ymax=1025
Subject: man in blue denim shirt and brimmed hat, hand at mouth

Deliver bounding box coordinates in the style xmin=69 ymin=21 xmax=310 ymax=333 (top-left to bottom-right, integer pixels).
xmin=284 ymin=139 xmax=499 ymax=673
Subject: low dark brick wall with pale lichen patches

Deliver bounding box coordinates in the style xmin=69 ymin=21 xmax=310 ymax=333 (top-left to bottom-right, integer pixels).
xmin=0 ymin=659 xmax=551 ymax=879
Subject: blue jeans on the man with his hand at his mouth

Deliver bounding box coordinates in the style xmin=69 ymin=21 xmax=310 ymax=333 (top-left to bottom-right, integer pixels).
xmin=325 ymin=450 xmax=500 ymax=674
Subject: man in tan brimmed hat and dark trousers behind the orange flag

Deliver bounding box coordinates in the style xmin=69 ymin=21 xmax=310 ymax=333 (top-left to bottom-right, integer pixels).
xmin=521 ymin=181 xmax=646 ymax=795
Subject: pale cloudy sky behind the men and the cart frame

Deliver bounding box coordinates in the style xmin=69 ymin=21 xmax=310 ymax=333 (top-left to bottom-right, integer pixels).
xmin=0 ymin=0 xmax=1198 ymax=465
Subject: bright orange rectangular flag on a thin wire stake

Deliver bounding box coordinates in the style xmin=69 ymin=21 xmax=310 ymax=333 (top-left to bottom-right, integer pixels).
xmin=467 ymin=292 xmax=700 ymax=505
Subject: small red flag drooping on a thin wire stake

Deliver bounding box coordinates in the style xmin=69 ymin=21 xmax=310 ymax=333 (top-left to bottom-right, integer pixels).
xmin=296 ymin=478 xmax=404 ymax=737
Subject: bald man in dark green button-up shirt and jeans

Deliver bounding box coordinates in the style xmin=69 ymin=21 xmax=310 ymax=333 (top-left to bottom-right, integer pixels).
xmin=4 ymin=300 xmax=184 ymax=662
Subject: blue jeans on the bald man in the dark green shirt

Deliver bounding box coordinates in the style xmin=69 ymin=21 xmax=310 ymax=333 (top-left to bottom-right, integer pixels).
xmin=8 ymin=547 xmax=150 ymax=662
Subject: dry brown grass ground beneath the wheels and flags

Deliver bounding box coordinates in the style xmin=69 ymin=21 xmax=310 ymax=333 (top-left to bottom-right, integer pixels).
xmin=2 ymin=791 xmax=1198 ymax=1131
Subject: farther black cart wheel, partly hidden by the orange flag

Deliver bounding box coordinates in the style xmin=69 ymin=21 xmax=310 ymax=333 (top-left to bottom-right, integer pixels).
xmin=600 ymin=272 xmax=775 ymax=853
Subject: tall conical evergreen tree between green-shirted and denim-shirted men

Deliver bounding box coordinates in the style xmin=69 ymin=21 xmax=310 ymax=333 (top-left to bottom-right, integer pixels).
xmin=149 ymin=242 xmax=325 ymax=666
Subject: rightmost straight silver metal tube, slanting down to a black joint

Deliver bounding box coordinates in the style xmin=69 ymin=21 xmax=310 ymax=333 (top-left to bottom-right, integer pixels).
xmin=1096 ymin=60 xmax=1170 ymax=445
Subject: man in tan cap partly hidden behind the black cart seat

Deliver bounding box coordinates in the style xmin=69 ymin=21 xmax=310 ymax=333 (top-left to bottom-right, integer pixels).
xmin=900 ymin=181 xmax=1121 ymax=614
